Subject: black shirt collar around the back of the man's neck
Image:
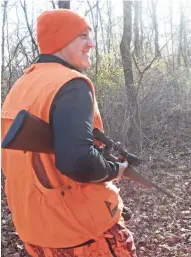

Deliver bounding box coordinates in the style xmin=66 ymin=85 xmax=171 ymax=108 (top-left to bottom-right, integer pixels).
xmin=37 ymin=54 xmax=80 ymax=72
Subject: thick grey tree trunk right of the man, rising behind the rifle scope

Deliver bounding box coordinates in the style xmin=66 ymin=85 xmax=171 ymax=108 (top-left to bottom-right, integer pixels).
xmin=120 ymin=1 xmax=140 ymax=150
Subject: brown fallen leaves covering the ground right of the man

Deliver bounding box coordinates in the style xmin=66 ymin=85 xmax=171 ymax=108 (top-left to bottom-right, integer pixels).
xmin=120 ymin=161 xmax=191 ymax=257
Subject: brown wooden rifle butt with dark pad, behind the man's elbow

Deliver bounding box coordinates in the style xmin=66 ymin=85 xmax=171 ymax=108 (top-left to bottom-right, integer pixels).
xmin=1 ymin=110 xmax=54 ymax=154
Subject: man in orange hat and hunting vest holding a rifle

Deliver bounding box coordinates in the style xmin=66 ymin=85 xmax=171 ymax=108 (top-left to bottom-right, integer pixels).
xmin=2 ymin=10 xmax=136 ymax=257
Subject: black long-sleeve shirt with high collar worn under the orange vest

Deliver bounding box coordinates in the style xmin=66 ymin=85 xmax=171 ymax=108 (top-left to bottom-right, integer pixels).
xmin=37 ymin=55 xmax=118 ymax=183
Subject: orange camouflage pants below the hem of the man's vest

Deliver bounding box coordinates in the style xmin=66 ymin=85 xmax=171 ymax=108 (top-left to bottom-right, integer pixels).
xmin=25 ymin=221 xmax=137 ymax=257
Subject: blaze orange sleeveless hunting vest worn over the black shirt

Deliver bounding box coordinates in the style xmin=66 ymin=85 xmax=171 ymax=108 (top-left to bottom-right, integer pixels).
xmin=2 ymin=63 xmax=123 ymax=248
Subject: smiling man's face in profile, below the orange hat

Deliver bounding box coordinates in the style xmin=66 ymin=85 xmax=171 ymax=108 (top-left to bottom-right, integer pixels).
xmin=61 ymin=30 xmax=95 ymax=70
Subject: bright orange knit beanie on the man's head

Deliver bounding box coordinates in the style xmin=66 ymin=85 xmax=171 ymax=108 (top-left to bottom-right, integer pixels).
xmin=37 ymin=9 xmax=91 ymax=54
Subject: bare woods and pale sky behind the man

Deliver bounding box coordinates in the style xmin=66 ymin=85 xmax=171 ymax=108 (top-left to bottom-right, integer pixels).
xmin=1 ymin=0 xmax=191 ymax=257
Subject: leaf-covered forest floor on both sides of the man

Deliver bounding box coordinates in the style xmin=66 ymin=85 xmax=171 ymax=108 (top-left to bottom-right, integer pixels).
xmin=1 ymin=151 xmax=191 ymax=257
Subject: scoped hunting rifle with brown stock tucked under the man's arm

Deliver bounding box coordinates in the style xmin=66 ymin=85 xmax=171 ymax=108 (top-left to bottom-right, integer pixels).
xmin=1 ymin=110 xmax=175 ymax=198
